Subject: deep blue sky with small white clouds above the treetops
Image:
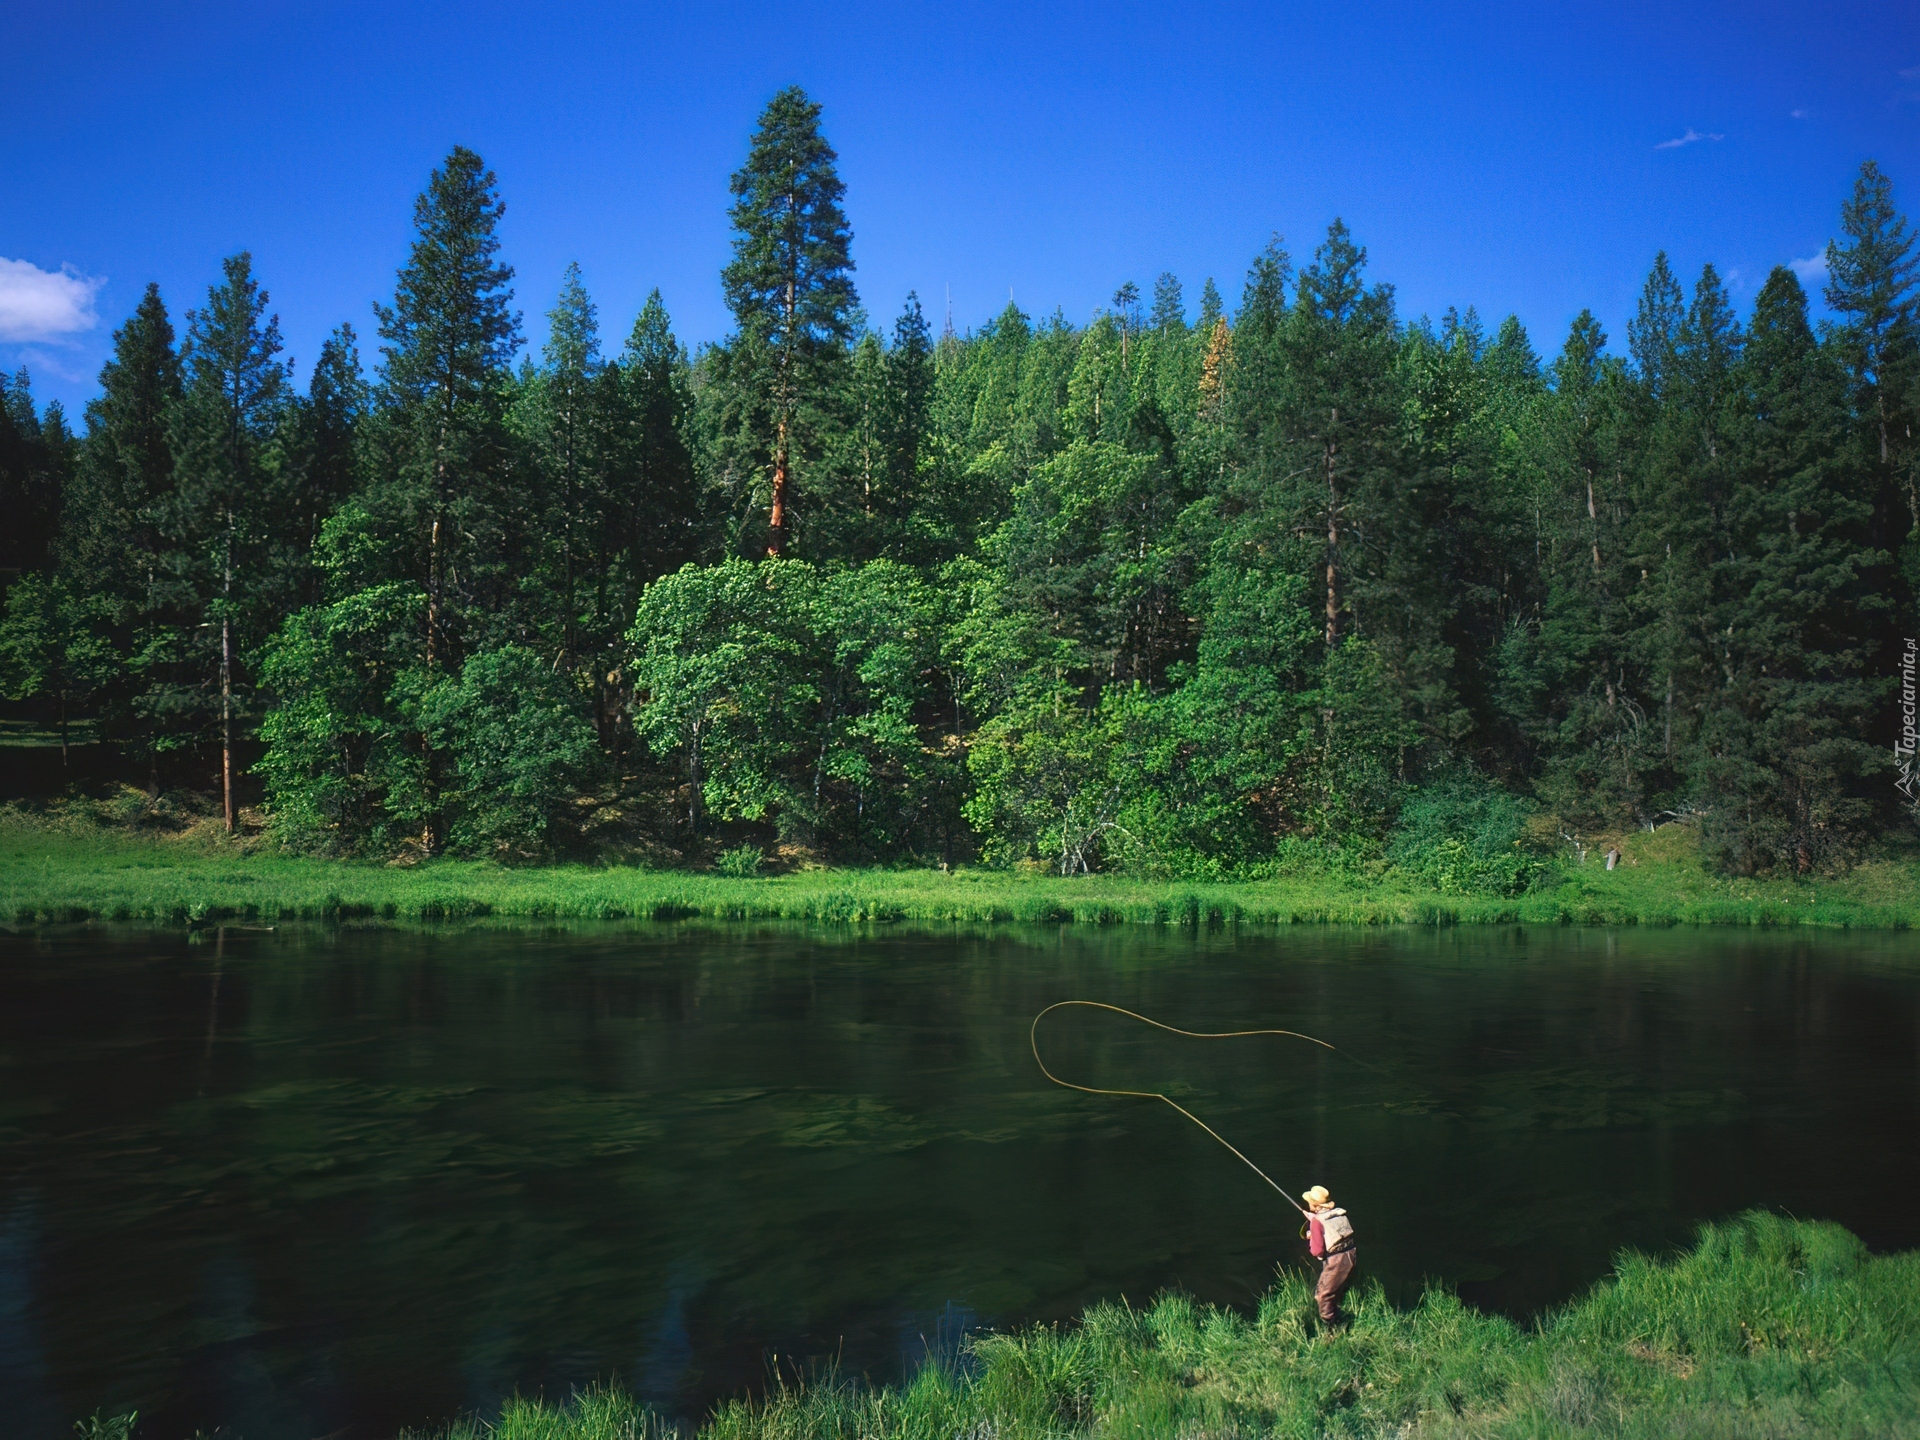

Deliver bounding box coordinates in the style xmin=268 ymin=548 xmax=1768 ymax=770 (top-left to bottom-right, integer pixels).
xmin=0 ymin=0 xmax=1920 ymax=409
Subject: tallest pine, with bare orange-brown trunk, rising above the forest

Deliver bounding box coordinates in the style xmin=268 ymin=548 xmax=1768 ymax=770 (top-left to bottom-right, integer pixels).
xmin=720 ymin=86 xmax=858 ymax=557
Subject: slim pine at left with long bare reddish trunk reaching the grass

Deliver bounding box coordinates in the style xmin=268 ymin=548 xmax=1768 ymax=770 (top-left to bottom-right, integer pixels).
xmin=167 ymin=252 xmax=288 ymax=833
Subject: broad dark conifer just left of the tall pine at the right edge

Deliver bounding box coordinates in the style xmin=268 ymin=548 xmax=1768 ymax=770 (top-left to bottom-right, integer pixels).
xmin=1693 ymin=269 xmax=1889 ymax=874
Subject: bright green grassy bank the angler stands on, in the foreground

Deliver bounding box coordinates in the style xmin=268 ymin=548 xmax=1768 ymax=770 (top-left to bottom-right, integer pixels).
xmin=417 ymin=1213 xmax=1920 ymax=1440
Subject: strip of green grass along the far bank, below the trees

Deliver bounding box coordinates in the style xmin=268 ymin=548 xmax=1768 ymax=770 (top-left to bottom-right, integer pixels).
xmin=0 ymin=810 xmax=1920 ymax=929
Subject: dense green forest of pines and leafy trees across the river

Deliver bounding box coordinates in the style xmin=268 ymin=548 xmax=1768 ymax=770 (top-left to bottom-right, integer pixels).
xmin=0 ymin=88 xmax=1920 ymax=895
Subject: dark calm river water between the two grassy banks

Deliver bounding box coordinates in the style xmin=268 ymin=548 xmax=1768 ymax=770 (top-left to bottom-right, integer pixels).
xmin=0 ymin=925 xmax=1920 ymax=1440
